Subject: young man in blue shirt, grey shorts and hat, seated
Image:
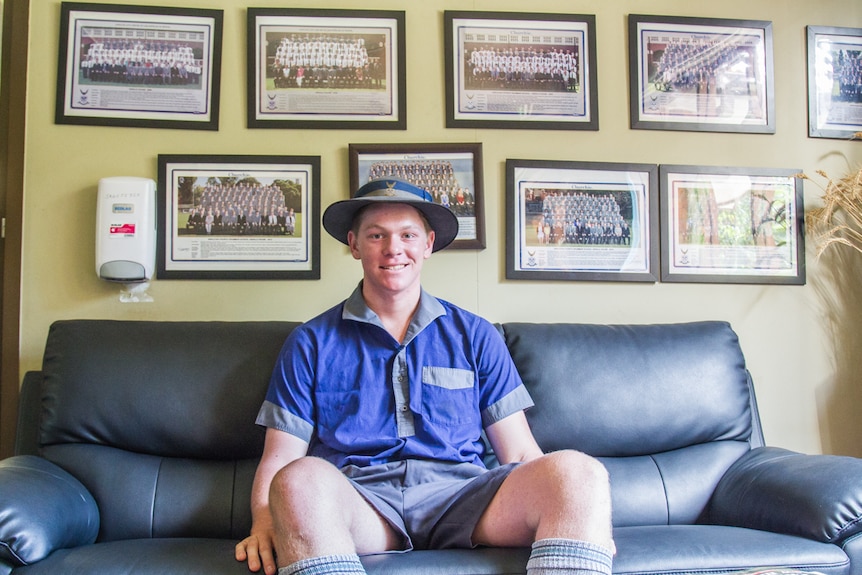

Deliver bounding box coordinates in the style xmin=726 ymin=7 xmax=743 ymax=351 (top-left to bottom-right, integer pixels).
xmin=236 ymin=180 xmax=614 ymax=575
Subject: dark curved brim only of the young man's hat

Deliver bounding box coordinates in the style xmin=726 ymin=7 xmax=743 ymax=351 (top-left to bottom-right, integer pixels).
xmin=323 ymin=196 xmax=458 ymax=252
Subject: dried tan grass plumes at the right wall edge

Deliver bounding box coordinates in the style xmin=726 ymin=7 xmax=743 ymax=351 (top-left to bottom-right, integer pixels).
xmin=798 ymin=132 xmax=862 ymax=256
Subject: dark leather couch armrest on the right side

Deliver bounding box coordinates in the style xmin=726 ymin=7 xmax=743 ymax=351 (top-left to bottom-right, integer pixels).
xmin=706 ymin=447 xmax=862 ymax=544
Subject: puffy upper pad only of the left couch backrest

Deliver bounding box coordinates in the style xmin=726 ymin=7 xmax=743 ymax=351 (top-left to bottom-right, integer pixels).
xmin=41 ymin=320 xmax=297 ymax=459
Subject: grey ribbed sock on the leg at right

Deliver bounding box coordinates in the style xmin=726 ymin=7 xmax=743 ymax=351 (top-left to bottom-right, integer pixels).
xmin=527 ymin=539 xmax=613 ymax=575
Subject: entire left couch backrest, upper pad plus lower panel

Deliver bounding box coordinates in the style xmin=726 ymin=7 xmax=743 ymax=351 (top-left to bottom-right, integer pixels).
xmin=34 ymin=320 xmax=298 ymax=541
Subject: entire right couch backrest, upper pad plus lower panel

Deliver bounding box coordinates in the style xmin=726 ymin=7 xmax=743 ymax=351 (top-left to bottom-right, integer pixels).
xmin=500 ymin=321 xmax=762 ymax=526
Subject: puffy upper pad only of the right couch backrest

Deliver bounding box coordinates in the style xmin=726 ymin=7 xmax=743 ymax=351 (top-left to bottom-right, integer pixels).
xmin=502 ymin=322 xmax=751 ymax=457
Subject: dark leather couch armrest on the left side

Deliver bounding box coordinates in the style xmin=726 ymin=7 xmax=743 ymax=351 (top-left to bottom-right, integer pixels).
xmin=0 ymin=455 xmax=99 ymax=565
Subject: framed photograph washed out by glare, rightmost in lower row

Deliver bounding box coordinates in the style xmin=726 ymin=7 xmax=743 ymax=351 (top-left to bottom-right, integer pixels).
xmin=659 ymin=165 xmax=805 ymax=285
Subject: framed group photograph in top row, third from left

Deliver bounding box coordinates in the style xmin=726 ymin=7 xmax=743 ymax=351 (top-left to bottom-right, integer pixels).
xmin=443 ymin=10 xmax=599 ymax=130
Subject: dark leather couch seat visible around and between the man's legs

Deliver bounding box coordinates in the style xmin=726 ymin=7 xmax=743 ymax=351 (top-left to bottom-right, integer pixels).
xmin=13 ymin=525 xmax=850 ymax=575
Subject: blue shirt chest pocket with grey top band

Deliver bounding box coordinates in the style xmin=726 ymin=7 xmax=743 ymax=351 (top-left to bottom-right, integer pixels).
xmin=422 ymin=366 xmax=479 ymax=425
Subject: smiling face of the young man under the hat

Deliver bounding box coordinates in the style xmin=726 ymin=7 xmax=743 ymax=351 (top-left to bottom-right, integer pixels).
xmin=347 ymin=203 xmax=434 ymax=297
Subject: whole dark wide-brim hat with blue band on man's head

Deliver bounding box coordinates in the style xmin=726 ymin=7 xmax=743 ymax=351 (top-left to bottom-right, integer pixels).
xmin=323 ymin=178 xmax=458 ymax=252
